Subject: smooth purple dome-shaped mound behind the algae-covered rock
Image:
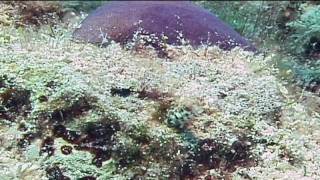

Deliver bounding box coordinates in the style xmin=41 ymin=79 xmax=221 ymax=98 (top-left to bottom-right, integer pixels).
xmin=73 ymin=1 xmax=256 ymax=51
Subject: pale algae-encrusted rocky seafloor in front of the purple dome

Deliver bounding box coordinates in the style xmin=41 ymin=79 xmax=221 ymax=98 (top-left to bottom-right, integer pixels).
xmin=0 ymin=1 xmax=320 ymax=180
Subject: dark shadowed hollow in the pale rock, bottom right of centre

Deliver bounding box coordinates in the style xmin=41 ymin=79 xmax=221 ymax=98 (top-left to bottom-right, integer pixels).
xmin=176 ymin=136 xmax=255 ymax=179
